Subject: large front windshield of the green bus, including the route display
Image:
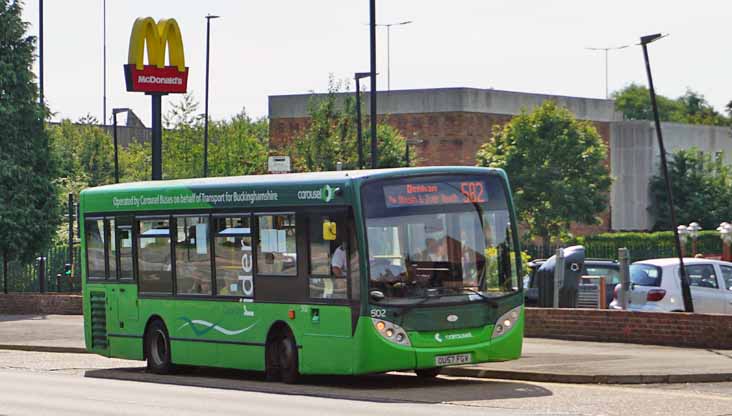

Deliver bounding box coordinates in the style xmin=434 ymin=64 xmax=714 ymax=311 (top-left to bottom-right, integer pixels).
xmin=363 ymin=175 xmax=518 ymax=303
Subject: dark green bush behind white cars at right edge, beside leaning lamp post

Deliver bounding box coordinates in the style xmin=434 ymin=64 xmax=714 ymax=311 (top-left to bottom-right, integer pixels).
xmin=650 ymin=148 xmax=732 ymax=230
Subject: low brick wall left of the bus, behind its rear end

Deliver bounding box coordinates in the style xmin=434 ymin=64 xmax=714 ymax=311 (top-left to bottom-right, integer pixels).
xmin=0 ymin=293 xmax=82 ymax=315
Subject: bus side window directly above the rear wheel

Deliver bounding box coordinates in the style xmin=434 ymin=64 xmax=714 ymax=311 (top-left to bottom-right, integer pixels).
xmin=137 ymin=219 xmax=173 ymax=294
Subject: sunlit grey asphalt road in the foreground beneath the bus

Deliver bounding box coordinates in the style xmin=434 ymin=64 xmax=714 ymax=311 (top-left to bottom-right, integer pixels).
xmin=0 ymin=351 xmax=732 ymax=416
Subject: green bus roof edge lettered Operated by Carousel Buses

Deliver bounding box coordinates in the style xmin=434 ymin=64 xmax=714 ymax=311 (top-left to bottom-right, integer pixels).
xmin=80 ymin=166 xmax=505 ymax=212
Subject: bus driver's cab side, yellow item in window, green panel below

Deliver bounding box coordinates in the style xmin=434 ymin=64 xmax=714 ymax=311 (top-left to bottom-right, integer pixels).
xmin=302 ymin=209 xmax=353 ymax=373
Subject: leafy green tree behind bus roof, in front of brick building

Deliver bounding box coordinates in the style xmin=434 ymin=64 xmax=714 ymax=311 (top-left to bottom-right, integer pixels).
xmin=285 ymin=79 xmax=406 ymax=172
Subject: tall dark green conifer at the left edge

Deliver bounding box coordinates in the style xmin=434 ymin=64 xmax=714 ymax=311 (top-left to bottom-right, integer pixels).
xmin=0 ymin=0 xmax=60 ymax=262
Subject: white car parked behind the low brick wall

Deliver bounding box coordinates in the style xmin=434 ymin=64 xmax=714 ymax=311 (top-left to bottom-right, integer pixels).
xmin=610 ymin=258 xmax=732 ymax=315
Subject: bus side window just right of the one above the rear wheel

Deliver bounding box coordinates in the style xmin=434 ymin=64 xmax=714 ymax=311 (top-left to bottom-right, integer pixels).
xmin=175 ymin=217 xmax=211 ymax=295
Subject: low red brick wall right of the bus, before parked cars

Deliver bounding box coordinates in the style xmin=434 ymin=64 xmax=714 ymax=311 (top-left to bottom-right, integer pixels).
xmin=525 ymin=308 xmax=732 ymax=349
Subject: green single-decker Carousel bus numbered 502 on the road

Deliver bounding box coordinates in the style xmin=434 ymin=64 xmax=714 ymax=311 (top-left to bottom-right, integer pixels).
xmin=80 ymin=167 xmax=524 ymax=382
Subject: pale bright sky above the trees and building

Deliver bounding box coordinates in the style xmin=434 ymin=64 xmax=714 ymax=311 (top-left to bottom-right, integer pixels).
xmin=24 ymin=0 xmax=732 ymax=125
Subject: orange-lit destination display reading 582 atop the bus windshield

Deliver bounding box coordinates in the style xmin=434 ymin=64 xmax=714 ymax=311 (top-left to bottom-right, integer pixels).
xmin=384 ymin=181 xmax=487 ymax=208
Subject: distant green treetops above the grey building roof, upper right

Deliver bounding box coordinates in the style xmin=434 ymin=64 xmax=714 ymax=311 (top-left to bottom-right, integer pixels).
xmin=612 ymin=84 xmax=730 ymax=126
